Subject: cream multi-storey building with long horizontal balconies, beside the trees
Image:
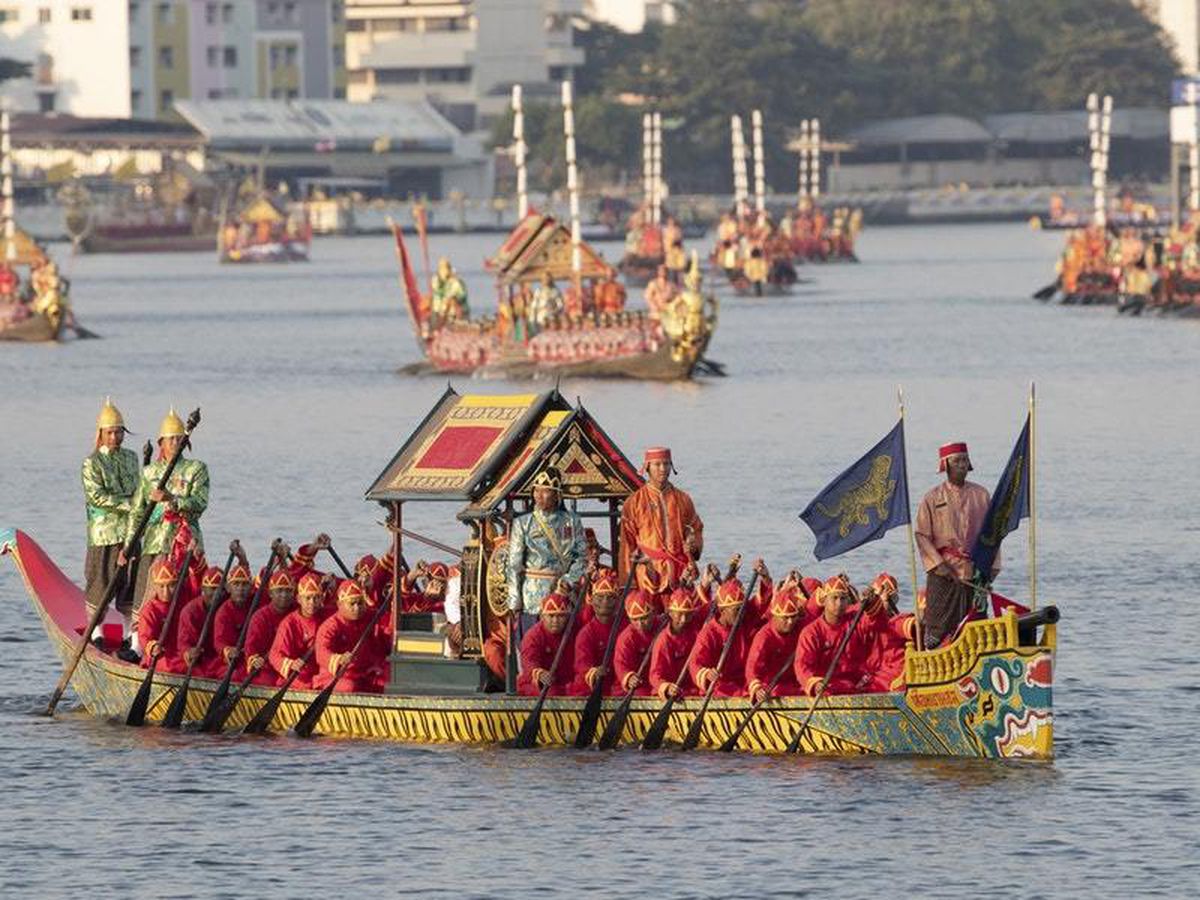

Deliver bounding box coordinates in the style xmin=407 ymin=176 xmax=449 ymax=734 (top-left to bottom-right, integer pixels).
xmin=346 ymin=0 xmax=583 ymax=130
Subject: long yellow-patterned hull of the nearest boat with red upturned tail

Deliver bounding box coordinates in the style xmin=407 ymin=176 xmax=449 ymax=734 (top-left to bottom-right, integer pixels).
xmin=0 ymin=529 xmax=1056 ymax=760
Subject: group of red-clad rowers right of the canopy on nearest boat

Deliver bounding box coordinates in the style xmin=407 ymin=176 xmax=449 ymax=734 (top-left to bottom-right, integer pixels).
xmin=513 ymin=559 xmax=914 ymax=702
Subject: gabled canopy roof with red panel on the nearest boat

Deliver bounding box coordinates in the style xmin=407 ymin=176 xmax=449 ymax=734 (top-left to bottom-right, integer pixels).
xmin=366 ymin=389 xmax=642 ymax=520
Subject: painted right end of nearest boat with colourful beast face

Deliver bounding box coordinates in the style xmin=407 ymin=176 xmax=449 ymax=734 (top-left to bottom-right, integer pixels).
xmin=905 ymin=606 xmax=1058 ymax=760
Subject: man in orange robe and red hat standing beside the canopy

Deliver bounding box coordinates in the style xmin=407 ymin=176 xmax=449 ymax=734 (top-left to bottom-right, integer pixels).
xmin=619 ymin=446 xmax=704 ymax=608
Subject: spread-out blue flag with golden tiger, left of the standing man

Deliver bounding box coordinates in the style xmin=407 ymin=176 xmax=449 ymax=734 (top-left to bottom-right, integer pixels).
xmin=800 ymin=420 xmax=910 ymax=559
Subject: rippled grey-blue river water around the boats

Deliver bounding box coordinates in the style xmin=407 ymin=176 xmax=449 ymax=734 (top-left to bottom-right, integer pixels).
xmin=0 ymin=224 xmax=1200 ymax=898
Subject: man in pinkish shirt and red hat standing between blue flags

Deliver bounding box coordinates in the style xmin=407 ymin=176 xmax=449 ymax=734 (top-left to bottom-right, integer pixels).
xmin=916 ymin=443 xmax=1000 ymax=650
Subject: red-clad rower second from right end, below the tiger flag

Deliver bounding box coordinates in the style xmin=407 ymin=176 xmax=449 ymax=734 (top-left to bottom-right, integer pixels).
xmin=794 ymin=577 xmax=871 ymax=697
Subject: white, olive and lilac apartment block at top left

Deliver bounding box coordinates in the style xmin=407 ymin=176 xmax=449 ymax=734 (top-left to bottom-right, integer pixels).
xmin=0 ymin=0 xmax=346 ymax=119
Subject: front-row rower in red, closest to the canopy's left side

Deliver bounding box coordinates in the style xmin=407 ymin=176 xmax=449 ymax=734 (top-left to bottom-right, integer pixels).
xmin=312 ymin=581 xmax=388 ymax=694
